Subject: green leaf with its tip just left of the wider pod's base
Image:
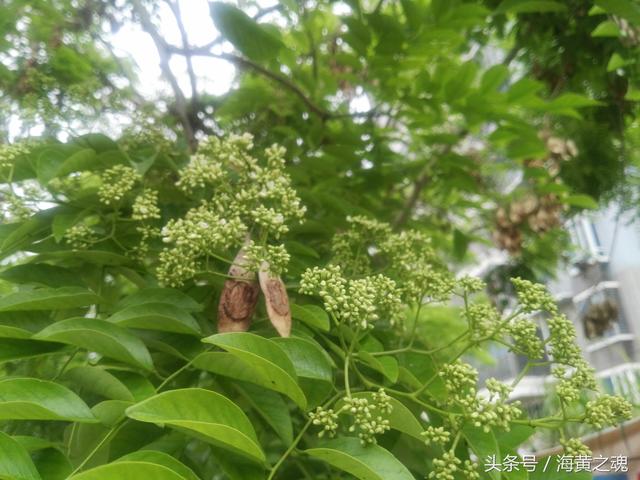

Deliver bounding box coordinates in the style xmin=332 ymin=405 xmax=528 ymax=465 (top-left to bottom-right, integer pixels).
xmin=107 ymin=303 xmax=201 ymax=336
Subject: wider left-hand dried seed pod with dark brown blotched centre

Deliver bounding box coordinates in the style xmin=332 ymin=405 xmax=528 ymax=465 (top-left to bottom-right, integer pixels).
xmin=218 ymin=248 xmax=260 ymax=333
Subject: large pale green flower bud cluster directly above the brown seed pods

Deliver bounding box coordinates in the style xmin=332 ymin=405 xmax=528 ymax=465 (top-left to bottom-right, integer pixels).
xmin=158 ymin=134 xmax=306 ymax=286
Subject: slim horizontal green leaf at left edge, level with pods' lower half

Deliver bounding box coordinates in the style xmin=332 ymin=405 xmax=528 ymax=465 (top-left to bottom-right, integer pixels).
xmin=0 ymin=287 xmax=100 ymax=312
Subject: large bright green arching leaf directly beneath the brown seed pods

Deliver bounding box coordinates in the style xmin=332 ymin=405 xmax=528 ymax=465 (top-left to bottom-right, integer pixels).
xmin=203 ymin=332 xmax=307 ymax=410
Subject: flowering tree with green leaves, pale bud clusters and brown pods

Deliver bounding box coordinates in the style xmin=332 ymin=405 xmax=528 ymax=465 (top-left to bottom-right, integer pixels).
xmin=0 ymin=1 xmax=635 ymax=480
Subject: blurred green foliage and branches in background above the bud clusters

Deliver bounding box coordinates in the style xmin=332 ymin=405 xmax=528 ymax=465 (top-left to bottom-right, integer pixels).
xmin=0 ymin=0 xmax=640 ymax=284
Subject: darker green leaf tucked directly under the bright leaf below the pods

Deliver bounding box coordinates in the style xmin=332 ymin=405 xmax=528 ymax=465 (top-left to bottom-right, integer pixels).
xmin=235 ymin=382 xmax=293 ymax=445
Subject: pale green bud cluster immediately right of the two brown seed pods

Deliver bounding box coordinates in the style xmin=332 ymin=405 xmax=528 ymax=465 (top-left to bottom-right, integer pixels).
xmin=300 ymin=265 xmax=402 ymax=329
